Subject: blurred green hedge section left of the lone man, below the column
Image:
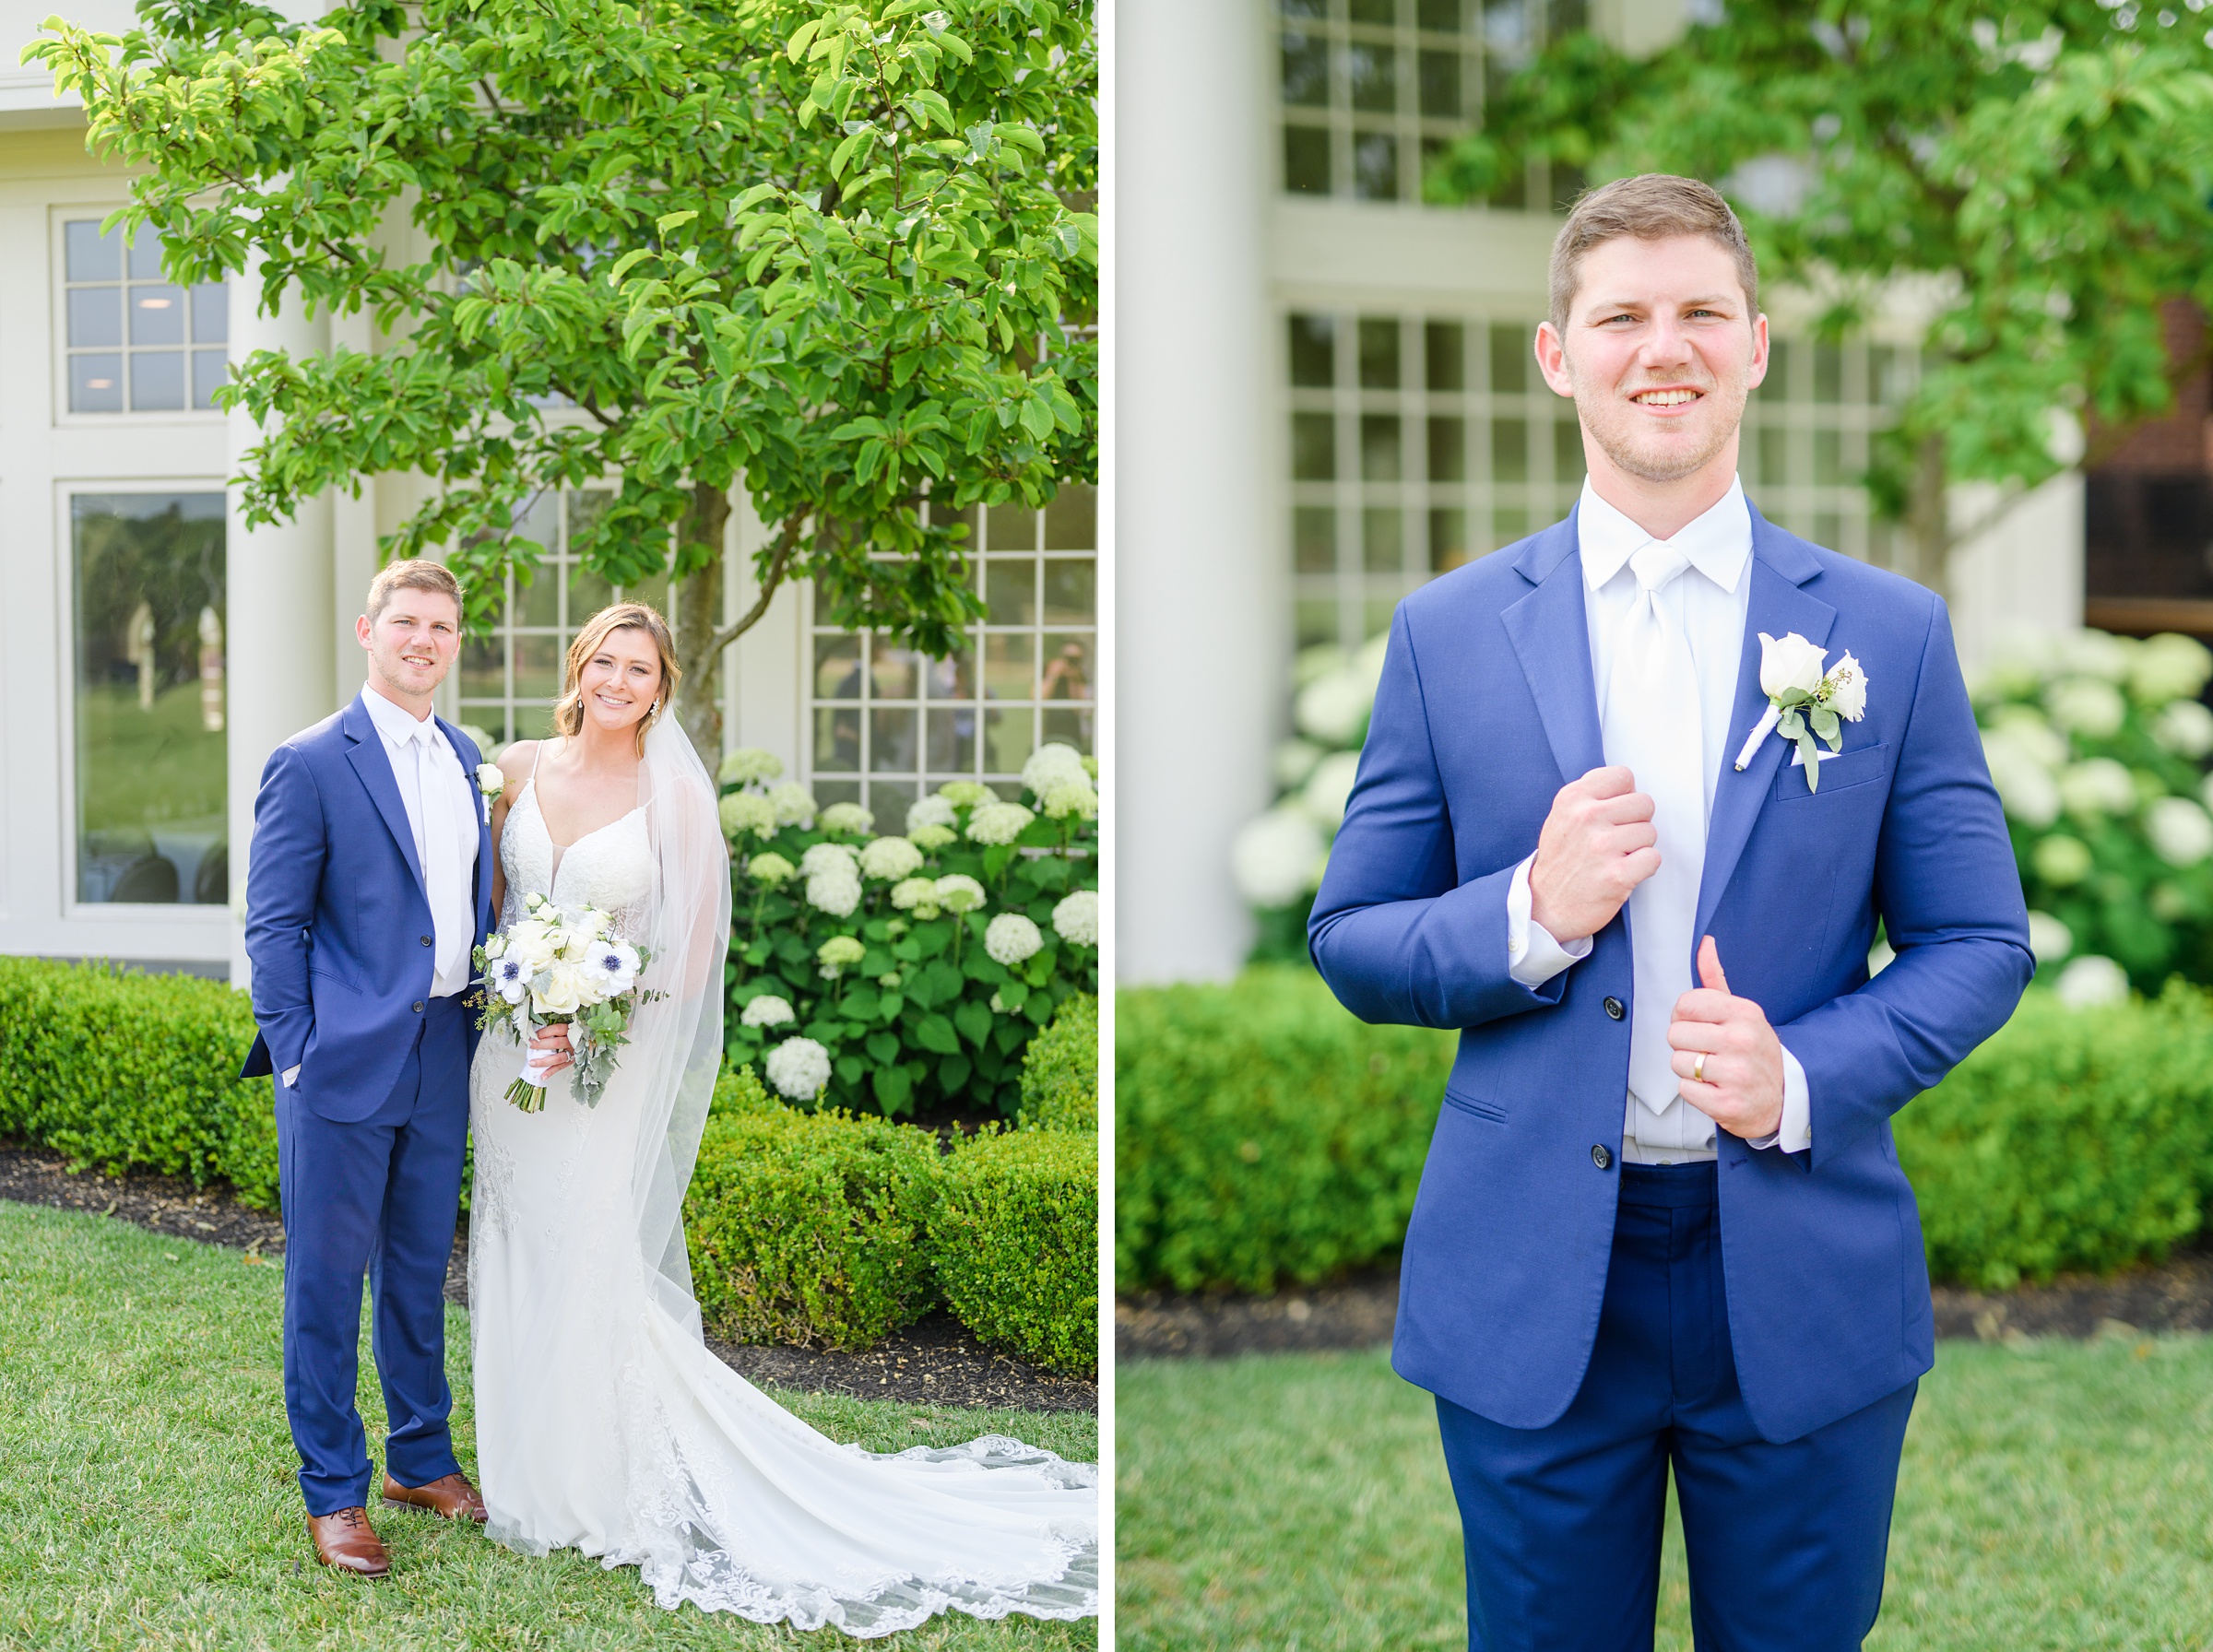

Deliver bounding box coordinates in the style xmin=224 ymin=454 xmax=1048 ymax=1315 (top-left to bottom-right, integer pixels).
xmin=1116 ymin=966 xmax=1454 ymax=1292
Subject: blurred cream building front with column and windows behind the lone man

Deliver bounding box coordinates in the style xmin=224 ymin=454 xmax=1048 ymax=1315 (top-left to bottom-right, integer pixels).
xmin=1111 ymin=0 xmax=2082 ymax=982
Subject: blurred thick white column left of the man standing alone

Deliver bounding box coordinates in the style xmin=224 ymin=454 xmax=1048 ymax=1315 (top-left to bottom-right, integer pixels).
xmin=1111 ymin=0 xmax=1290 ymax=982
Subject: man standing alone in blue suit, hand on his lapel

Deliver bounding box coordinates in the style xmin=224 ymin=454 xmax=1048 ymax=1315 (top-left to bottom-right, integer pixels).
xmin=1310 ymin=175 xmax=2034 ymax=1652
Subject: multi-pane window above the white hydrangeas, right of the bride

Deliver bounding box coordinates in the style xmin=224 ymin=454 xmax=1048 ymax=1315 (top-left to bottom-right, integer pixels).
xmin=808 ymin=484 xmax=1097 ymax=813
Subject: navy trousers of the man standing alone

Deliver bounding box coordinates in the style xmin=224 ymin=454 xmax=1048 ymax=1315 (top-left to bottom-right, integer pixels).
xmin=1437 ymin=1163 xmax=1916 ymax=1652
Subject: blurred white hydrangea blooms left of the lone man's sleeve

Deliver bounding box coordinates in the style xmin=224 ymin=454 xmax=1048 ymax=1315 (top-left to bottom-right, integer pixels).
xmin=1230 ymin=634 xmax=1385 ymax=962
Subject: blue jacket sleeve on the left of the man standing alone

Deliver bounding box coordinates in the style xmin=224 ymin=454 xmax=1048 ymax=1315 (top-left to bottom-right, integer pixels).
xmin=1306 ymin=606 xmax=1567 ymax=1029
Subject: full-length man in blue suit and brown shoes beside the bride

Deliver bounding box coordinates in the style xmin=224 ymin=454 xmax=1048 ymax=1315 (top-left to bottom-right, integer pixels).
xmin=243 ymin=561 xmax=491 ymax=1576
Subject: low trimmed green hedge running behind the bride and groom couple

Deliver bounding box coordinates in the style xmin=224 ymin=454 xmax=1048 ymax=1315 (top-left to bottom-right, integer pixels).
xmin=0 ymin=958 xmax=1097 ymax=1371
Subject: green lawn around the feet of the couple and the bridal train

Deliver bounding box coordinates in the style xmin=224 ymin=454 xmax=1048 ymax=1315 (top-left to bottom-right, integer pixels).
xmin=0 ymin=1203 xmax=1097 ymax=1652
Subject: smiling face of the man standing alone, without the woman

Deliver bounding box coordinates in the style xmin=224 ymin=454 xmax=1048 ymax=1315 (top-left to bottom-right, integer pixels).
xmin=1536 ymin=234 xmax=1769 ymax=493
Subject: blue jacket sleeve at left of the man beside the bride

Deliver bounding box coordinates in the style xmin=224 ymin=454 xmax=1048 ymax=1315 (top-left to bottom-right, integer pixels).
xmin=245 ymin=745 xmax=330 ymax=1072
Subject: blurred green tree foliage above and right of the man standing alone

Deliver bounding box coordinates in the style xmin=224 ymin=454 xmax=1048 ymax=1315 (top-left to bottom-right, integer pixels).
xmin=1427 ymin=0 xmax=2213 ymax=588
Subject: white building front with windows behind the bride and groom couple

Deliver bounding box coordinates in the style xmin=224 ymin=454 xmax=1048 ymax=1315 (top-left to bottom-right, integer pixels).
xmin=0 ymin=0 xmax=1100 ymax=982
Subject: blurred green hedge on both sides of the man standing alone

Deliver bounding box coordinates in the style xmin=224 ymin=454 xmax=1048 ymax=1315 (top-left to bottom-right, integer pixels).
xmin=1116 ymin=966 xmax=2213 ymax=1292
